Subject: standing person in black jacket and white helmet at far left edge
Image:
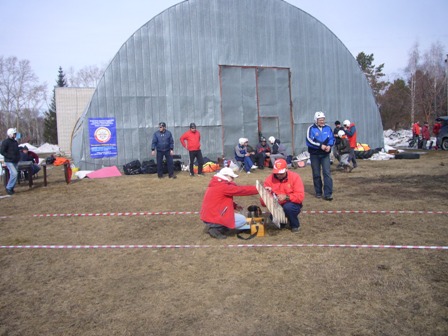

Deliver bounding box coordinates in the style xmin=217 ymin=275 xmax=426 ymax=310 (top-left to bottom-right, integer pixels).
xmin=0 ymin=128 xmax=20 ymax=195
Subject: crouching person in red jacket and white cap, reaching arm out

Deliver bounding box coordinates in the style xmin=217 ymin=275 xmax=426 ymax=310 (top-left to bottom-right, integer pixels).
xmin=200 ymin=167 xmax=258 ymax=239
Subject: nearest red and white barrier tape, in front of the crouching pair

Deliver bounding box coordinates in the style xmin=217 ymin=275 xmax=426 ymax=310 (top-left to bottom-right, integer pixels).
xmin=0 ymin=244 xmax=448 ymax=250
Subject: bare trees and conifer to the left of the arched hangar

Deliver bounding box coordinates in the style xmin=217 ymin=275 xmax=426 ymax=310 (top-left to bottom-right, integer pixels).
xmin=0 ymin=56 xmax=104 ymax=146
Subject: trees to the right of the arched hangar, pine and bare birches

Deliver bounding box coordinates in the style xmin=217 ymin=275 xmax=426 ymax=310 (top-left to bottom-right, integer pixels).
xmin=356 ymin=42 xmax=448 ymax=130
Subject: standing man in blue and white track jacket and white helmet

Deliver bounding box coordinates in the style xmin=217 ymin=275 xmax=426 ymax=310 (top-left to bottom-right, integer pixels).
xmin=306 ymin=112 xmax=334 ymax=201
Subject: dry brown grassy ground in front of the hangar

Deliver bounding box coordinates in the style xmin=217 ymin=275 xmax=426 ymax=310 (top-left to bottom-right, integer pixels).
xmin=0 ymin=151 xmax=448 ymax=336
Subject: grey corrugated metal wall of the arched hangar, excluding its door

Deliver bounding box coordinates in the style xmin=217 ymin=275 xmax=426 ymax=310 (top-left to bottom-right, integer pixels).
xmin=72 ymin=0 xmax=383 ymax=169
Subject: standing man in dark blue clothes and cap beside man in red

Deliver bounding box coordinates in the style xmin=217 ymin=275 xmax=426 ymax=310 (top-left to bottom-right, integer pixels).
xmin=151 ymin=122 xmax=176 ymax=179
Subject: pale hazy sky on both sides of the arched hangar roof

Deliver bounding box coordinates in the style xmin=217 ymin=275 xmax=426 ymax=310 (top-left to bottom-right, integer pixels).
xmin=0 ymin=0 xmax=448 ymax=88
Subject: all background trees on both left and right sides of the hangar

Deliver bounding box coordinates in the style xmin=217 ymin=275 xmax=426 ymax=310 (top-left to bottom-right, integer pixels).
xmin=0 ymin=42 xmax=448 ymax=145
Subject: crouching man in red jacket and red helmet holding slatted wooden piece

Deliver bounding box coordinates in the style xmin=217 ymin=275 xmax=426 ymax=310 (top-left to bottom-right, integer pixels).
xmin=262 ymin=159 xmax=305 ymax=233
